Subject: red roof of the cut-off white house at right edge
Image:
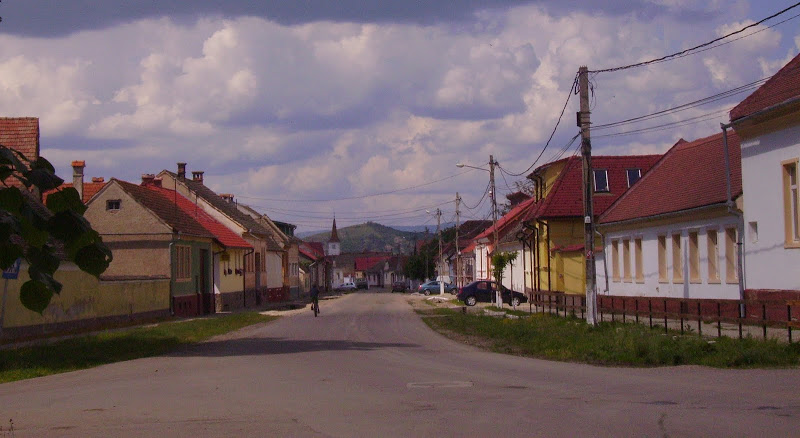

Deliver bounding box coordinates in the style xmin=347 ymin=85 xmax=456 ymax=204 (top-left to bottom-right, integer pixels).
xmin=730 ymin=55 xmax=800 ymax=121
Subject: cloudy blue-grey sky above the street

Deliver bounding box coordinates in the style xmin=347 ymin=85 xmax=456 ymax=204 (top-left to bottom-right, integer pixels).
xmin=0 ymin=0 xmax=800 ymax=231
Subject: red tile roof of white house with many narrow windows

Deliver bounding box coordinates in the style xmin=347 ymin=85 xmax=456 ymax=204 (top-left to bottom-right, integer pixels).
xmin=599 ymin=131 xmax=742 ymax=223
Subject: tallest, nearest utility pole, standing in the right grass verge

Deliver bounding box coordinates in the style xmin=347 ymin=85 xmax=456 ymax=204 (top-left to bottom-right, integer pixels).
xmin=578 ymin=66 xmax=597 ymax=325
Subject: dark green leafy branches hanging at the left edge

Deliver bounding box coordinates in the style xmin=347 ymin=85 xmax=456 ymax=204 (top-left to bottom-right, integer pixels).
xmin=0 ymin=145 xmax=112 ymax=314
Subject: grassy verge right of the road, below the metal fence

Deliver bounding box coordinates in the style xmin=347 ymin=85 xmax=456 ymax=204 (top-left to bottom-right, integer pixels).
xmin=424 ymin=309 xmax=800 ymax=368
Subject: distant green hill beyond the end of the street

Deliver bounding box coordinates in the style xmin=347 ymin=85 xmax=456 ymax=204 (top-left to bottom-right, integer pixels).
xmin=303 ymin=222 xmax=436 ymax=254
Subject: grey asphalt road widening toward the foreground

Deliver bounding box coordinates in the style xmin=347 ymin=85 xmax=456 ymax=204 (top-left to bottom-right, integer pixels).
xmin=0 ymin=293 xmax=800 ymax=438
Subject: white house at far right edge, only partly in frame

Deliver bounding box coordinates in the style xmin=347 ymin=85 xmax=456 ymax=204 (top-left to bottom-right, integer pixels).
xmin=730 ymin=55 xmax=800 ymax=297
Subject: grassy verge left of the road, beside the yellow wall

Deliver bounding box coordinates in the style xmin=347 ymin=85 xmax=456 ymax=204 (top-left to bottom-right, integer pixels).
xmin=0 ymin=312 xmax=277 ymax=383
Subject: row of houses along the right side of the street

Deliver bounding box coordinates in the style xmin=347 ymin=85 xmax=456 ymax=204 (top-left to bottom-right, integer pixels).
xmin=450 ymin=51 xmax=800 ymax=299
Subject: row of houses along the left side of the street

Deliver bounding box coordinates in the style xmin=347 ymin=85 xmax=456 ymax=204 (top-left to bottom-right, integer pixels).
xmin=0 ymin=126 xmax=332 ymax=338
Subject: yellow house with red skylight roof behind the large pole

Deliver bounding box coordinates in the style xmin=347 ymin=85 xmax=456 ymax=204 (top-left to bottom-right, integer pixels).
xmin=517 ymin=155 xmax=661 ymax=294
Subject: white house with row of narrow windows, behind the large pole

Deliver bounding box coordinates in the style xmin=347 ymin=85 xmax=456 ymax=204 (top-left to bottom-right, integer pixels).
xmin=596 ymin=132 xmax=742 ymax=299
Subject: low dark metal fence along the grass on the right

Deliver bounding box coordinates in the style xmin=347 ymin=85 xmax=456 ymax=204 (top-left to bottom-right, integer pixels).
xmin=528 ymin=291 xmax=800 ymax=342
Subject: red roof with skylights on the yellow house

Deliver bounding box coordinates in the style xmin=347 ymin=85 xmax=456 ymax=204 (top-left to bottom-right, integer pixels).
xmin=526 ymin=155 xmax=661 ymax=220
